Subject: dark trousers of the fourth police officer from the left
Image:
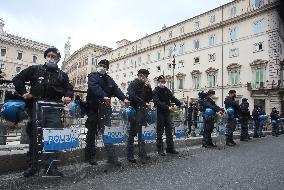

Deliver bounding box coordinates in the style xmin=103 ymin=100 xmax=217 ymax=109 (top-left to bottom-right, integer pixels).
xmin=157 ymin=111 xmax=174 ymax=150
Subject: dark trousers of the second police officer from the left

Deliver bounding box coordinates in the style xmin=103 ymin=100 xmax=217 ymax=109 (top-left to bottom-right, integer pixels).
xmin=85 ymin=109 xmax=118 ymax=163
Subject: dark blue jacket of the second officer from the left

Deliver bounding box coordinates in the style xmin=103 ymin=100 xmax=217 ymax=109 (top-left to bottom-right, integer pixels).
xmin=86 ymin=72 xmax=125 ymax=112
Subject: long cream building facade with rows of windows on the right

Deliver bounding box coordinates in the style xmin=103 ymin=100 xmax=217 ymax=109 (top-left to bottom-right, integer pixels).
xmin=64 ymin=0 xmax=284 ymax=112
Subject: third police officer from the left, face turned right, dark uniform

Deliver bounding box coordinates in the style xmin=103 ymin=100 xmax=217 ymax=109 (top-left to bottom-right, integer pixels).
xmin=127 ymin=69 xmax=152 ymax=163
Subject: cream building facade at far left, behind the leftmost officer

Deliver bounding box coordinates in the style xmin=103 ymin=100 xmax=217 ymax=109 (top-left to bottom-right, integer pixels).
xmin=0 ymin=19 xmax=49 ymax=103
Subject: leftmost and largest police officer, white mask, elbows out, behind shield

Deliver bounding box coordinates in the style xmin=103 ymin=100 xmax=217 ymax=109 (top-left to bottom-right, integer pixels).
xmin=13 ymin=47 xmax=74 ymax=177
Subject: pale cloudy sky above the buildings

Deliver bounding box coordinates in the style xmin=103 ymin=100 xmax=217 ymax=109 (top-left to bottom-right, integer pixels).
xmin=0 ymin=0 xmax=232 ymax=58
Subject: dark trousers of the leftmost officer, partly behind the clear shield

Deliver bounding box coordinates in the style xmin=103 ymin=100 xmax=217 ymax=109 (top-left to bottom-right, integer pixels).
xmin=26 ymin=104 xmax=63 ymax=167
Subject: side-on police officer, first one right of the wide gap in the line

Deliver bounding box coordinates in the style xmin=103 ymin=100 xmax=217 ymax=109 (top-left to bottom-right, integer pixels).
xmin=202 ymin=90 xmax=222 ymax=148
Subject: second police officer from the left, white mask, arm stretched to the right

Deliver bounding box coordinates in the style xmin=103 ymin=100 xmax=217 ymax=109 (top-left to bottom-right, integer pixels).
xmin=85 ymin=59 xmax=128 ymax=166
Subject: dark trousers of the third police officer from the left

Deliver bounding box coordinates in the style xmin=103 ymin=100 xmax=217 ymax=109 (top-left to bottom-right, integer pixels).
xmin=126 ymin=108 xmax=148 ymax=159
